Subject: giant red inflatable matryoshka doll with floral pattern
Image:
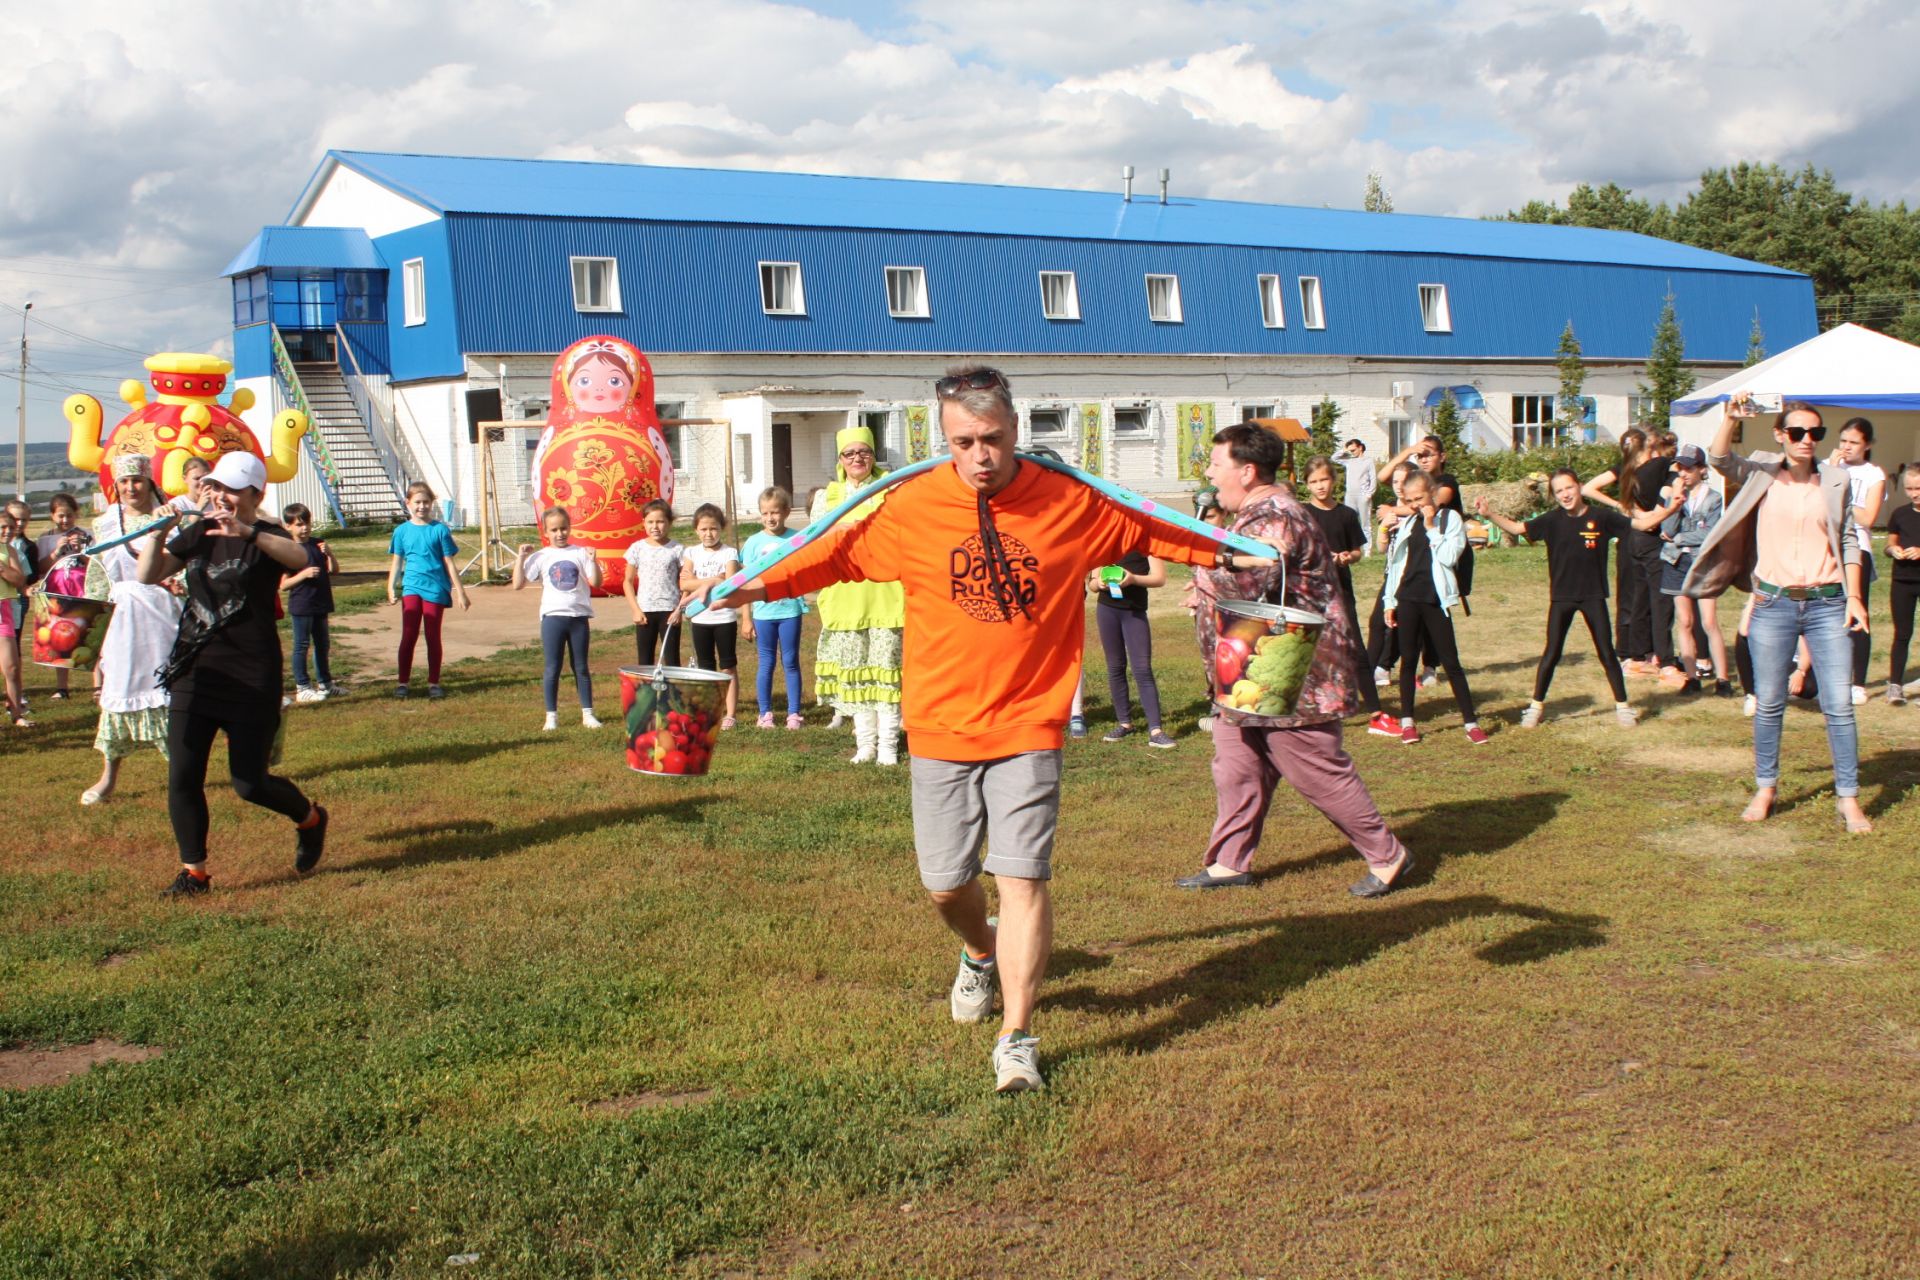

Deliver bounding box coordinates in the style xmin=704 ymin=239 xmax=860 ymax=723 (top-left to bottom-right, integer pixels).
xmin=534 ymin=334 xmax=674 ymax=595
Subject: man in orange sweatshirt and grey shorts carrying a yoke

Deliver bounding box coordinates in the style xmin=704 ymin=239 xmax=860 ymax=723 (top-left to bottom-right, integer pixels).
xmin=703 ymin=367 xmax=1269 ymax=1094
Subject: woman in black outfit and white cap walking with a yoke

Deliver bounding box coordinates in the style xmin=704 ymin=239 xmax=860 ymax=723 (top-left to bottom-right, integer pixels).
xmin=140 ymin=453 xmax=326 ymax=898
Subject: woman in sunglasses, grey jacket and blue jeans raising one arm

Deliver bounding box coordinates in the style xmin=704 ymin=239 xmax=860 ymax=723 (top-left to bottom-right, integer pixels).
xmin=1682 ymin=397 xmax=1874 ymax=833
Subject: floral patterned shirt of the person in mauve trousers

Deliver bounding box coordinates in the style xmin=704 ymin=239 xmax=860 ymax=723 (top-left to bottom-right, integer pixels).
xmin=1194 ymin=493 xmax=1359 ymax=729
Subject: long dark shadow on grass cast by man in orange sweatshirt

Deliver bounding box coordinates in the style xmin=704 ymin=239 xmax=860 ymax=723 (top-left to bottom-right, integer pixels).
xmin=1046 ymin=894 xmax=1609 ymax=1057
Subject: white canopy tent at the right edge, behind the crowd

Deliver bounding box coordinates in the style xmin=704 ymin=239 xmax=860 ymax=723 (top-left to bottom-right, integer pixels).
xmin=1672 ymin=324 xmax=1920 ymax=518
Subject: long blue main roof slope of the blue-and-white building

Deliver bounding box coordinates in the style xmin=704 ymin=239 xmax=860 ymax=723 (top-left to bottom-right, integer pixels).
xmin=307 ymin=152 xmax=1795 ymax=276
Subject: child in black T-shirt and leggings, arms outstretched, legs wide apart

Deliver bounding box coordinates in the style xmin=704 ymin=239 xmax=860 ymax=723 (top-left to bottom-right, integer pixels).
xmin=1475 ymin=470 xmax=1665 ymax=729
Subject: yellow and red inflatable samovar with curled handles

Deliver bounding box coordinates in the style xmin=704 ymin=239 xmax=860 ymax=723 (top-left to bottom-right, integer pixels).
xmin=61 ymin=351 xmax=307 ymax=503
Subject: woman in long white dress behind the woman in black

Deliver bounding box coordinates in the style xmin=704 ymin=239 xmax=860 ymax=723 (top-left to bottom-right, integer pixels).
xmin=81 ymin=453 xmax=180 ymax=804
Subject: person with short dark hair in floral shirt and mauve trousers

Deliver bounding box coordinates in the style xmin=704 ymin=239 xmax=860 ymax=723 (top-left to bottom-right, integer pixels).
xmin=1175 ymin=422 xmax=1413 ymax=898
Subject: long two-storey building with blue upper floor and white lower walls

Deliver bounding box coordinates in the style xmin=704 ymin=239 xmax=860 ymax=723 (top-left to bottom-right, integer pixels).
xmin=227 ymin=152 xmax=1816 ymax=518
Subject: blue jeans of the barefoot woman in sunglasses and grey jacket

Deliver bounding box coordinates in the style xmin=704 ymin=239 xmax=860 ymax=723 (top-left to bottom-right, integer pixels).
xmin=1747 ymin=593 xmax=1860 ymax=796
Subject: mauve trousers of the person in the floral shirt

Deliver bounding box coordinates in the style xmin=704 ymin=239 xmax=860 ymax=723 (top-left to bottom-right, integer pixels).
xmin=1206 ymin=716 xmax=1405 ymax=871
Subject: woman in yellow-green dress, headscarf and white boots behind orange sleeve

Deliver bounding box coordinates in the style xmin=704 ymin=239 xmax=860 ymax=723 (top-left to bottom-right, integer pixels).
xmin=806 ymin=426 xmax=906 ymax=764
